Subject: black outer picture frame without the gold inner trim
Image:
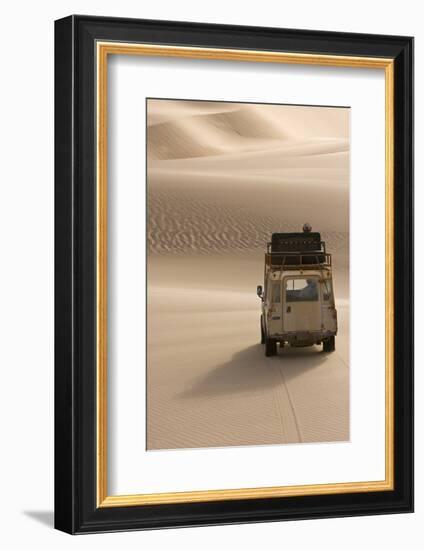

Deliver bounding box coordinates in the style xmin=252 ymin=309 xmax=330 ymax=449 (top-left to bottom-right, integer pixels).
xmin=55 ymin=15 xmax=414 ymax=534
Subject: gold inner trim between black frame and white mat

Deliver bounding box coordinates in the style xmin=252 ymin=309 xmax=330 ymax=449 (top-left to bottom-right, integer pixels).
xmin=96 ymin=41 xmax=394 ymax=507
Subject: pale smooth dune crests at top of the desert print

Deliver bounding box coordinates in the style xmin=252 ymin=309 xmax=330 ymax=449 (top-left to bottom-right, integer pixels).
xmin=147 ymin=100 xmax=348 ymax=160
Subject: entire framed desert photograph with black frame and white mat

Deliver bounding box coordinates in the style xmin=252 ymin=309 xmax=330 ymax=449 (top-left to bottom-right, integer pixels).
xmin=55 ymin=16 xmax=413 ymax=534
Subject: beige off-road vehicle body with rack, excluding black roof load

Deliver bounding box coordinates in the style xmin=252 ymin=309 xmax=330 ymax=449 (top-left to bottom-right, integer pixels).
xmin=257 ymin=232 xmax=337 ymax=356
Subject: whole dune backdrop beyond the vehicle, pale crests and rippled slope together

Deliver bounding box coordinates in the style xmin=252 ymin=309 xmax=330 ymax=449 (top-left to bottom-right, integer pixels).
xmin=148 ymin=101 xmax=349 ymax=255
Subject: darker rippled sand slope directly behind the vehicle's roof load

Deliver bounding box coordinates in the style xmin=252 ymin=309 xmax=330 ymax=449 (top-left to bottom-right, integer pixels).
xmin=147 ymin=173 xmax=349 ymax=254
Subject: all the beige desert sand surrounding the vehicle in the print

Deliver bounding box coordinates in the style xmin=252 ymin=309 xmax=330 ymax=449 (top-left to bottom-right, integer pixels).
xmin=147 ymin=100 xmax=349 ymax=449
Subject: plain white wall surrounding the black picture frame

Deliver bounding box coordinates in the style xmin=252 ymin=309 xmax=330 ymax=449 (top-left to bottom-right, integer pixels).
xmin=0 ymin=0 xmax=424 ymax=550
